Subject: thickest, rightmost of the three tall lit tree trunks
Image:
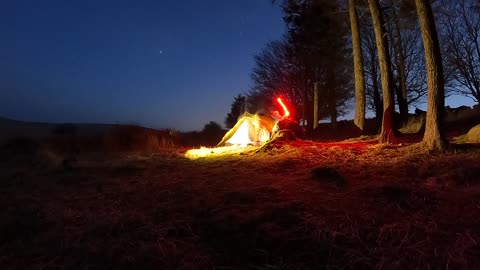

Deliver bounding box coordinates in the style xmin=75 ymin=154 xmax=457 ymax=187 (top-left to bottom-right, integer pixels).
xmin=415 ymin=0 xmax=446 ymax=151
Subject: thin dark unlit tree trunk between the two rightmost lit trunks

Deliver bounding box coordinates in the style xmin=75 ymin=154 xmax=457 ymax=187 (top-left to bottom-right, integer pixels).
xmin=390 ymin=1 xmax=408 ymax=125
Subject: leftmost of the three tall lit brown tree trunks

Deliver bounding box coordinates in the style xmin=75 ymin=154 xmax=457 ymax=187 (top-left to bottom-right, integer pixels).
xmin=349 ymin=0 xmax=365 ymax=130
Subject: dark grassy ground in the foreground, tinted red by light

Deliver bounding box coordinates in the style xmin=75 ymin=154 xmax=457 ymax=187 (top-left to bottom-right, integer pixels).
xmin=0 ymin=141 xmax=480 ymax=269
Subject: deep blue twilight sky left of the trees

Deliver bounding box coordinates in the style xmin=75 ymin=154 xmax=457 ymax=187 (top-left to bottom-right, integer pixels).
xmin=0 ymin=0 xmax=284 ymax=130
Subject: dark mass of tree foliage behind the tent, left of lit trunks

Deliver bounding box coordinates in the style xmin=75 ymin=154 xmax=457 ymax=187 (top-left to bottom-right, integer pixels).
xmin=249 ymin=0 xmax=352 ymax=130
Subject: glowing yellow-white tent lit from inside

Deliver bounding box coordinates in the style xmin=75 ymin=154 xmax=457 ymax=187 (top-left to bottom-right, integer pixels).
xmin=217 ymin=112 xmax=277 ymax=146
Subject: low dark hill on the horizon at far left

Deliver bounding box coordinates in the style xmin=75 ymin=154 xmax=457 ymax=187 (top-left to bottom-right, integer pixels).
xmin=0 ymin=117 xmax=115 ymax=141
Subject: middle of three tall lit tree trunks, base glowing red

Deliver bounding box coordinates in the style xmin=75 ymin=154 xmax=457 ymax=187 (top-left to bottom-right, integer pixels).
xmin=368 ymin=0 xmax=395 ymax=143
